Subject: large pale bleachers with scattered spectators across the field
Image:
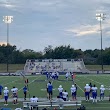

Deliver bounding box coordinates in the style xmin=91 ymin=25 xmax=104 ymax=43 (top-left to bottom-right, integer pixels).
xmin=24 ymin=59 xmax=87 ymax=73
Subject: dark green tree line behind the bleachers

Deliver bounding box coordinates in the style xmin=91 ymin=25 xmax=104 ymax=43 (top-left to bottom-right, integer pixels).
xmin=0 ymin=45 xmax=110 ymax=65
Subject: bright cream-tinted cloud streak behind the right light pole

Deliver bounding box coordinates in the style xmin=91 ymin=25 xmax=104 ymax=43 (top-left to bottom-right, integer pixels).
xmin=66 ymin=19 xmax=110 ymax=36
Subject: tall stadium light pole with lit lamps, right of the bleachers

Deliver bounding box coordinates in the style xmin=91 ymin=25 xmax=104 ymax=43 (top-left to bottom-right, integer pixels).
xmin=96 ymin=13 xmax=106 ymax=73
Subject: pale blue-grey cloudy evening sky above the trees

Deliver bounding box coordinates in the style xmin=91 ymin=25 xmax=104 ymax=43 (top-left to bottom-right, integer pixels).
xmin=0 ymin=0 xmax=110 ymax=51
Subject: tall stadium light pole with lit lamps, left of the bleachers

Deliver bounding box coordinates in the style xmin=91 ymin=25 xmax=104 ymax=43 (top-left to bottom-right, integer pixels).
xmin=3 ymin=16 xmax=13 ymax=72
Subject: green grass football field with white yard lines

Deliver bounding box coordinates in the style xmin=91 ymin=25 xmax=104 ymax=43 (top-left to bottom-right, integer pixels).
xmin=0 ymin=75 xmax=110 ymax=110
